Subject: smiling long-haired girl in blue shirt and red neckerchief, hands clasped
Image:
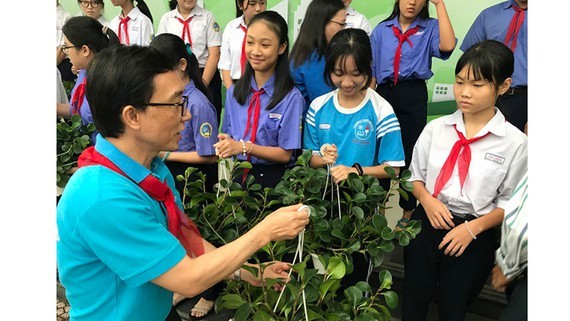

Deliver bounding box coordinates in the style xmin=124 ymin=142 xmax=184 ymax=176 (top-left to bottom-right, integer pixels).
xmin=215 ymin=11 xmax=305 ymax=187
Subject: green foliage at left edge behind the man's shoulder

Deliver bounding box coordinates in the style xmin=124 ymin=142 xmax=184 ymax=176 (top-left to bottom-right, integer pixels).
xmin=56 ymin=115 xmax=95 ymax=188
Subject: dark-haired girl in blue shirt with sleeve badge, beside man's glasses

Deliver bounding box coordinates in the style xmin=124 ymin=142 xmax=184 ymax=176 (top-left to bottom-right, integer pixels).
xmin=150 ymin=33 xmax=224 ymax=318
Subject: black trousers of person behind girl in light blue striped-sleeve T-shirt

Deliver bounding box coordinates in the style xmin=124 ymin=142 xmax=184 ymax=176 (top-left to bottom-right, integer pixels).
xmin=376 ymin=79 xmax=428 ymax=211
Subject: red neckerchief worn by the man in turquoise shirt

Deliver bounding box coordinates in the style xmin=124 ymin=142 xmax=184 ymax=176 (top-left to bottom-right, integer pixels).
xmin=77 ymin=146 xmax=204 ymax=257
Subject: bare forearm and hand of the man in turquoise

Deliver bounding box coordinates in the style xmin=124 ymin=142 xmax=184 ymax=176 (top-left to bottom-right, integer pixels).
xmin=152 ymin=204 xmax=309 ymax=297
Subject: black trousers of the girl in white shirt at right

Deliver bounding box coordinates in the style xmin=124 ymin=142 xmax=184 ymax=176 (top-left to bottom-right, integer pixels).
xmin=402 ymin=204 xmax=498 ymax=321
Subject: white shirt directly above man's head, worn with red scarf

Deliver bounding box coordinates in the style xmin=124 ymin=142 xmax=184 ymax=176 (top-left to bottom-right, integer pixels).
xmin=109 ymin=7 xmax=154 ymax=46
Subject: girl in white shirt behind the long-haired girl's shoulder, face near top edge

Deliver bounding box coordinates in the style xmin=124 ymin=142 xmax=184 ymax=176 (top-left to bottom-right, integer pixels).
xmin=218 ymin=0 xmax=267 ymax=89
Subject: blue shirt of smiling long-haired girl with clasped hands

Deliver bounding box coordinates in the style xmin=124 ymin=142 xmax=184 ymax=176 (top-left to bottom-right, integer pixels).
xmin=222 ymin=75 xmax=305 ymax=165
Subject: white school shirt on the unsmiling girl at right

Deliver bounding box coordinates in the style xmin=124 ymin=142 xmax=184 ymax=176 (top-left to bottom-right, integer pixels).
xmin=410 ymin=108 xmax=528 ymax=216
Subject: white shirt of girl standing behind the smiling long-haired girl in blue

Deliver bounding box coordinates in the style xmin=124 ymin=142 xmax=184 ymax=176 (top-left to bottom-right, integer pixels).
xmin=218 ymin=15 xmax=247 ymax=79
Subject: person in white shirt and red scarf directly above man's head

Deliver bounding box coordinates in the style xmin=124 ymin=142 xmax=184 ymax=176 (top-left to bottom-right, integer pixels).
xmin=109 ymin=0 xmax=154 ymax=46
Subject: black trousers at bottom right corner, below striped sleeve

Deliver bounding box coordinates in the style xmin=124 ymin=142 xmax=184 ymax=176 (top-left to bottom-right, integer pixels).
xmin=499 ymin=272 xmax=528 ymax=321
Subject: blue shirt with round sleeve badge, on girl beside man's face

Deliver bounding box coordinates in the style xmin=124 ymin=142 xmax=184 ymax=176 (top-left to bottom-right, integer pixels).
xmin=178 ymin=80 xmax=218 ymax=156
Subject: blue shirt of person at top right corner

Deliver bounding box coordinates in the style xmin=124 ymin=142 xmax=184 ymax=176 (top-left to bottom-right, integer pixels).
xmin=459 ymin=0 xmax=528 ymax=87
